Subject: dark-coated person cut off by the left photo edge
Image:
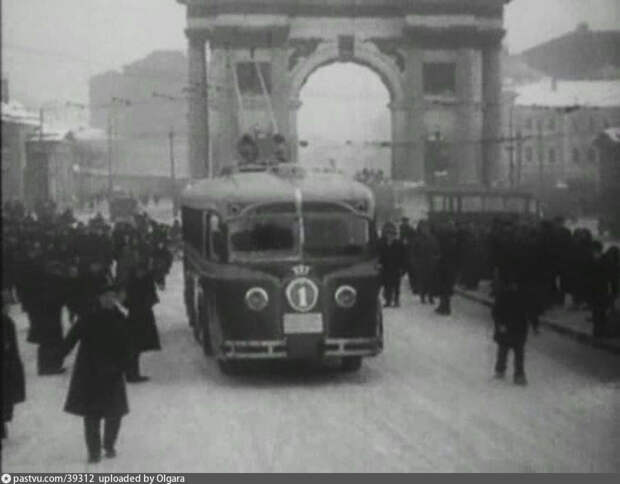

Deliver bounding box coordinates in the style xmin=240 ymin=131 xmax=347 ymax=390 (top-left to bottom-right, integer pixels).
xmin=2 ymin=287 xmax=26 ymax=439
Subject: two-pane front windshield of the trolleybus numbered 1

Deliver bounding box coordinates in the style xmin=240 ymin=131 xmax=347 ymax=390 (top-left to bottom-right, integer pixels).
xmin=229 ymin=208 xmax=371 ymax=260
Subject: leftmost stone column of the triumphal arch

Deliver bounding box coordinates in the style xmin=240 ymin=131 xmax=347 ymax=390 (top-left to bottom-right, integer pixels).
xmin=187 ymin=32 xmax=209 ymax=178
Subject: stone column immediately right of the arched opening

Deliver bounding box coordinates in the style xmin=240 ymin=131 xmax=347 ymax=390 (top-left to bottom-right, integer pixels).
xmin=398 ymin=46 xmax=426 ymax=181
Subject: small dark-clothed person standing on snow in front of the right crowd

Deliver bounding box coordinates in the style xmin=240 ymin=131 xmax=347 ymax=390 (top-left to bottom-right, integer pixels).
xmin=492 ymin=281 xmax=528 ymax=385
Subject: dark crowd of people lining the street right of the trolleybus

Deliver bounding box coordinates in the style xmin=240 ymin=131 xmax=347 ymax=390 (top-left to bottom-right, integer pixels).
xmin=379 ymin=218 xmax=620 ymax=384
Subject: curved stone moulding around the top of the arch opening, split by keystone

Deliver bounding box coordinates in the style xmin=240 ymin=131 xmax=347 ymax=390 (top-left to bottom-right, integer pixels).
xmin=289 ymin=42 xmax=405 ymax=104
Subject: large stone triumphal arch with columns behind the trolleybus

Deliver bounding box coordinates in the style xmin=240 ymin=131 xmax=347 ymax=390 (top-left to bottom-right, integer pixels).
xmin=177 ymin=0 xmax=508 ymax=184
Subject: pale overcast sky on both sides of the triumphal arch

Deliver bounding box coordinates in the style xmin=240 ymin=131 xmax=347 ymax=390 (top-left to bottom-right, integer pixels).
xmin=2 ymin=0 xmax=620 ymax=105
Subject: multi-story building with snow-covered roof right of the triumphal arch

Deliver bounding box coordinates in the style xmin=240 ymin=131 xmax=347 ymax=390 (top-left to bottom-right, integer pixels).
xmin=502 ymin=79 xmax=620 ymax=214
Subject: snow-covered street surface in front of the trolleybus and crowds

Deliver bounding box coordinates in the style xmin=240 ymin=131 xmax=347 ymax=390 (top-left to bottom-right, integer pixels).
xmin=2 ymin=263 xmax=620 ymax=472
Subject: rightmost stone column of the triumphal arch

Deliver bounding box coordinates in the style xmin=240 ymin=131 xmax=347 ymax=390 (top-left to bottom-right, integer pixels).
xmin=481 ymin=40 xmax=502 ymax=186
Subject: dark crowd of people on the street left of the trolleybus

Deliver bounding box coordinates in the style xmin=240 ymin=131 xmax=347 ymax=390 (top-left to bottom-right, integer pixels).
xmin=2 ymin=199 xmax=180 ymax=462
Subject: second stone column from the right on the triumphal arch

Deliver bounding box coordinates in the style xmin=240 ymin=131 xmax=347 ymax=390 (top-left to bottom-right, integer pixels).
xmin=450 ymin=48 xmax=481 ymax=185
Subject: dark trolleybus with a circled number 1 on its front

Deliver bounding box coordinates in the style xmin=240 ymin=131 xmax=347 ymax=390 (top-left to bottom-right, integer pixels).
xmin=181 ymin=163 xmax=383 ymax=373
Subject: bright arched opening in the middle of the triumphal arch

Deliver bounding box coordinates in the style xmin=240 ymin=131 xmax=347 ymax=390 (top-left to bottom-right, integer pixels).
xmin=295 ymin=60 xmax=394 ymax=178
